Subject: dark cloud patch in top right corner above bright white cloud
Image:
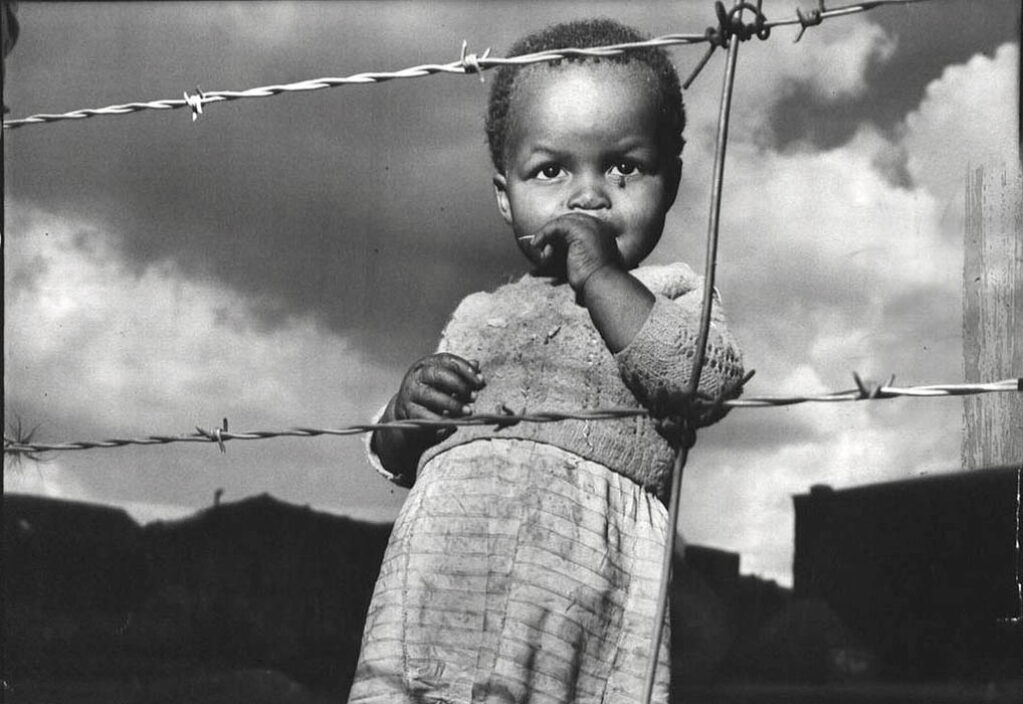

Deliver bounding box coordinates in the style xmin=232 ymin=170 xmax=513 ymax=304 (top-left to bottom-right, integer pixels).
xmin=768 ymin=0 xmax=1020 ymax=152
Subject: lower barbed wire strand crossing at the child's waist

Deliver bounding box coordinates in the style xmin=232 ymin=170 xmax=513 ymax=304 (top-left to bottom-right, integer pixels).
xmin=3 ymin=379 xmax=1023 ymax=454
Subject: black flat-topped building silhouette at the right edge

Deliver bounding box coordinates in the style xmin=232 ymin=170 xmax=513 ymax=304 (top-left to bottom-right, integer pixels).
xmin=794 ymin=467 xmax=1023 ymax=677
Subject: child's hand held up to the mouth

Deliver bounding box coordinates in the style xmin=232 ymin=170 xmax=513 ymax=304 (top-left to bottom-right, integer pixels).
xmin=531 ymin=212 xmax=622 ymax=293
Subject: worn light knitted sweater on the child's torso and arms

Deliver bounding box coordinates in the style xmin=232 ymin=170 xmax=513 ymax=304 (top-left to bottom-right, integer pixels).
xmin=395 ymin=263 xmax=743 ymax=498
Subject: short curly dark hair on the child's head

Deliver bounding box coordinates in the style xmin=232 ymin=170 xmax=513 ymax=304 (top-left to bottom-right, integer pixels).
xmin=486 ymin=18 xmax=685 ymax=173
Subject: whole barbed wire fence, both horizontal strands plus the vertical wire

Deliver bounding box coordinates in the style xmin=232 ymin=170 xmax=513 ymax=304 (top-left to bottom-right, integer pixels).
xmin=3 ymin=0 xmax=1002 ymax=704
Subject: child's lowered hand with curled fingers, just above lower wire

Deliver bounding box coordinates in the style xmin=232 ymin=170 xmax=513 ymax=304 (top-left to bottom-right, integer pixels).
xmin=394 ymin=352 xmax=485 ymax=425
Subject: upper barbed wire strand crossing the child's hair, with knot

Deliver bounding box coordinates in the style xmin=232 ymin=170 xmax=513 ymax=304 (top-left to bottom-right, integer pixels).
xmin=3 ymin=0 xmax=926 ymax=130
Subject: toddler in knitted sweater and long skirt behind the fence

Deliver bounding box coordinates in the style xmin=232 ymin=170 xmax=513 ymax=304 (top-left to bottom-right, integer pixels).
xmin=350 ymin=19 xmax=743 ymax=704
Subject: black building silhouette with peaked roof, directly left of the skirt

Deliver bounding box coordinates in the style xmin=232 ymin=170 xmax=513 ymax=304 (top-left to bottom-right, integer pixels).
xmin=141 ymin=494 xmax=391 ymax=683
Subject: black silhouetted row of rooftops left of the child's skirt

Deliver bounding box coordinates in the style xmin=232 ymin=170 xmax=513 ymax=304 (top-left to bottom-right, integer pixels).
xmin=2 ymin=494 xmax=391 ymax=701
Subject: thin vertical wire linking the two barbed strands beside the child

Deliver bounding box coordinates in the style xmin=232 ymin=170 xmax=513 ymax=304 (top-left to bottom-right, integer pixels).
xmin=642 ymin=26 xmax=740 ymax=704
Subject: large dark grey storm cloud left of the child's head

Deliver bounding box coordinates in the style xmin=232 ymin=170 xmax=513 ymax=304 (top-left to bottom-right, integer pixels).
xmin=7 ymin=3 xmax=716 ymax=362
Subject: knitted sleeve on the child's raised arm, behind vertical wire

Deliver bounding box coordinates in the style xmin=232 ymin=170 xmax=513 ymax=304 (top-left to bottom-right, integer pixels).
xmin=615 ymin=281 xmax=744 ymax=426
